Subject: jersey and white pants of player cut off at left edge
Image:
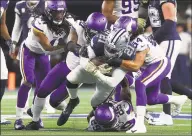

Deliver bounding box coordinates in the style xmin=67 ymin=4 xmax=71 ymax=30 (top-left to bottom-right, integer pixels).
xmin=0 ymin=0 xmax=9 ymax=80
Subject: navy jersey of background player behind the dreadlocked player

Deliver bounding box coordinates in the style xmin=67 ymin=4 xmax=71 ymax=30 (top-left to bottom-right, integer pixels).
xmin=15 ymin=0 xmax=44 ymax=41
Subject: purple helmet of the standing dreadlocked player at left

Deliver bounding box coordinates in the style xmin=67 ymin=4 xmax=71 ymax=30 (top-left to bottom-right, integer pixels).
xmin=45 ymin=0 xmax=67 ymax=25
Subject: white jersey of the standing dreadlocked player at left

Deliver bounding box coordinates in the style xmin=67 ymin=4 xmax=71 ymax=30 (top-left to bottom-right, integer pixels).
xmin=25 ymin=18 xmax=74 ymax=54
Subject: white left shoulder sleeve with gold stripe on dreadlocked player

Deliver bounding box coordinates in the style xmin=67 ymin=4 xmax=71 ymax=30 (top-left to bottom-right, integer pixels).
xmin=32 ymin=18 xmax=44 ymax=33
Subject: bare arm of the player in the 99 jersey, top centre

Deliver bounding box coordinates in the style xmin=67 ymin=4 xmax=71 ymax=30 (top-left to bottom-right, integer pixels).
xmin=102 ymin=0 xmax=118 ymax=23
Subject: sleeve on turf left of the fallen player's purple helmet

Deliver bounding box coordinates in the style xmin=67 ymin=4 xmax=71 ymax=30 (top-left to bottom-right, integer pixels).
xmin=87 ymin=116 xmax=104 ymax=131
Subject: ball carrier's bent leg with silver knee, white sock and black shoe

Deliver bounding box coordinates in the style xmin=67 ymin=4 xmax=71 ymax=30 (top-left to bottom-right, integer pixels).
xmin=57 ymin=65 xmax=95 ymax=126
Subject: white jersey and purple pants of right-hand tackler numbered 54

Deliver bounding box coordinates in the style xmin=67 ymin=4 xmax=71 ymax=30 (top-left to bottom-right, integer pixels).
xmin=129 ymin=35 xmax=171 ymax=106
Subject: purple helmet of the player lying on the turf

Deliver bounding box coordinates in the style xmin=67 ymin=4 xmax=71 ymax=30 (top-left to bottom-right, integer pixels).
xmin=95 ymin=103 xmax=117 ymax=128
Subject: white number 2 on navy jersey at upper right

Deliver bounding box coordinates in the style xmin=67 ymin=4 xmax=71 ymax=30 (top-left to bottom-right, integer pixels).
xmin=149 ymin=7 xmax=161 ymax=27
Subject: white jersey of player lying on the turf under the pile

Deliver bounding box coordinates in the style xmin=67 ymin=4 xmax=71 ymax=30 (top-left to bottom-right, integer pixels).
xmin=88 ymin=101 xmax=135 ymax=131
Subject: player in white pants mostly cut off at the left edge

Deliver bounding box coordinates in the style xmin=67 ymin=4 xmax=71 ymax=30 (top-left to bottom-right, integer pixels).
xmin=0 ymin=0 xmax=16 ymax=124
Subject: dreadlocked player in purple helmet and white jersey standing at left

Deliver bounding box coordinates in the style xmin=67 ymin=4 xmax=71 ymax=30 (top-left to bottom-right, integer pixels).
xmin=14 ymin=0 xmax=78 ymax=130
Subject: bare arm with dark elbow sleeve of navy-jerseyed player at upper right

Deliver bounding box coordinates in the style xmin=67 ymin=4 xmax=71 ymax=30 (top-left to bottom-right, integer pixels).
xmin=154 ymin=0 xmax=176 ymax=43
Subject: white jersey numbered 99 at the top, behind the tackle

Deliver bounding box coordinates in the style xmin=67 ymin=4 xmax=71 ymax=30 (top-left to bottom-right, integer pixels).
xmin=113 ymin=0 xmax=139 ymax=18
